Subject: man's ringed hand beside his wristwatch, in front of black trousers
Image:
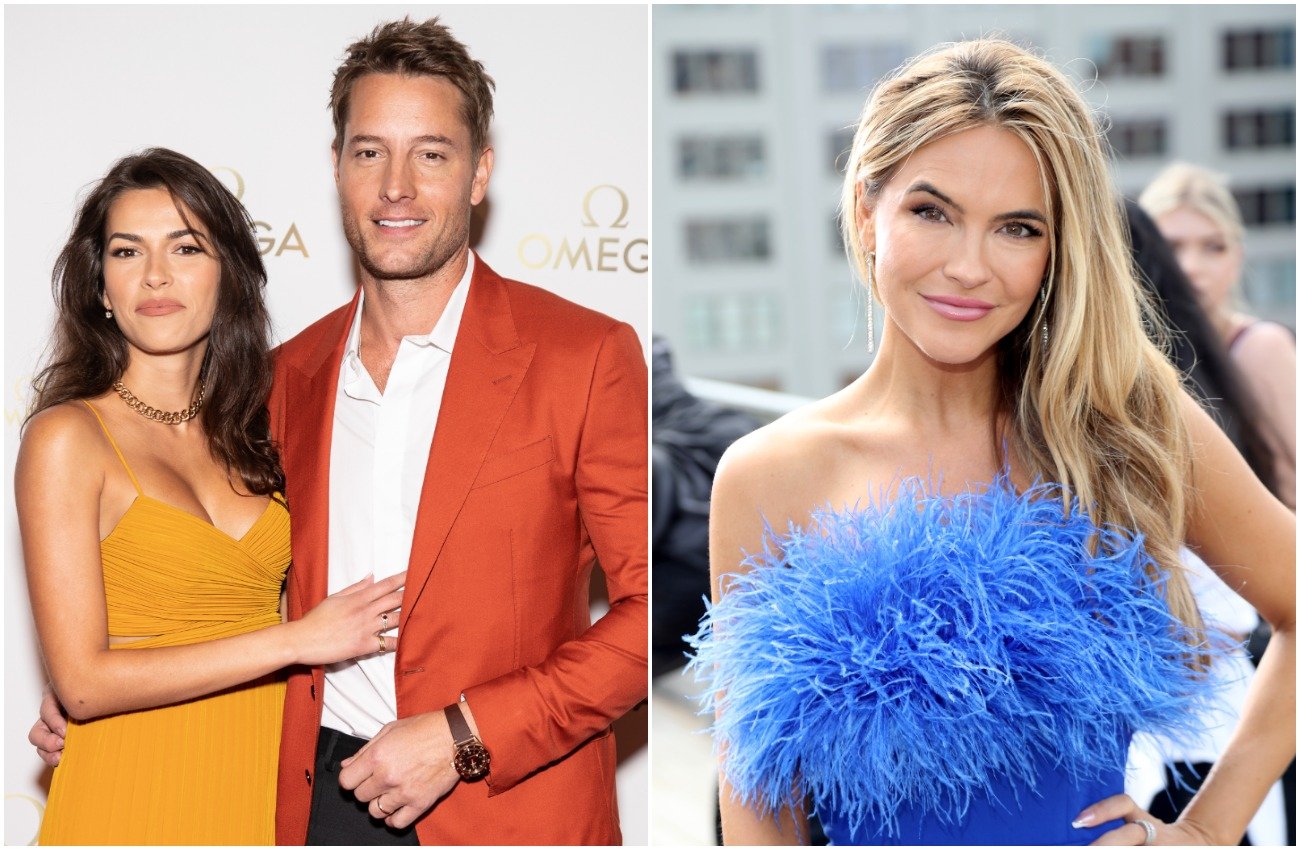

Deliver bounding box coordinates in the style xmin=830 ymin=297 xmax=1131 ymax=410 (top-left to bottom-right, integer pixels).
xmin=338 ymin=711 xmax=460 ymax=829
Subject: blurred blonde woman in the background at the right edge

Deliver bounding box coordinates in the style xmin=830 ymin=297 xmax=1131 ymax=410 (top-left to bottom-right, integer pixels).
xmin=1138 ymin=162 xmax=1296 ymax=509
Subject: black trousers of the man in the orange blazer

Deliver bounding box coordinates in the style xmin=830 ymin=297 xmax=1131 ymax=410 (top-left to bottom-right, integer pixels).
xmin=307 ymin=727 xmax=420 ymax=845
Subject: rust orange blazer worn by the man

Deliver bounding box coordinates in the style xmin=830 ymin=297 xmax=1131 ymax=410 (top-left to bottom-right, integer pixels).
xmin=270 ymin=260 xmax=647 ymax=845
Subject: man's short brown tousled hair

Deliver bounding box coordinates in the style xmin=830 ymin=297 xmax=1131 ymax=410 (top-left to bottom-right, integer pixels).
xmin=329 ymin=17 xmax=497 ymax=156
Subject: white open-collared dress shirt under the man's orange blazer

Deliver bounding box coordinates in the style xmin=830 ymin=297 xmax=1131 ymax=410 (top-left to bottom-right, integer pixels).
xmin=321 ymin=252 xmax=475 ymax=738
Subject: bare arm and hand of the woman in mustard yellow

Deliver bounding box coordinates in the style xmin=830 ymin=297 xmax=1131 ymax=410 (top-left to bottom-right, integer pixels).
xmin=16 ymin=407 xmax=404 ymax=720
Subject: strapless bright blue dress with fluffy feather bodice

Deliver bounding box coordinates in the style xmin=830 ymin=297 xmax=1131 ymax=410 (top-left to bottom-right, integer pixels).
xmin=690 ymin=474 xmax=1209 ymax=845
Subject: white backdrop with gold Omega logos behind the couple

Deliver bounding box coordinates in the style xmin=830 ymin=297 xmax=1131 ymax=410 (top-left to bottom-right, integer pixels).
xmin=4 ymin=5 xmax=649 ymax=845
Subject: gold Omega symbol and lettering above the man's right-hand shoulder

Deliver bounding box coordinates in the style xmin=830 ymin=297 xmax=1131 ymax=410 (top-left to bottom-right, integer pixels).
xmin=519 ymin=183 xmax=650 ymax=274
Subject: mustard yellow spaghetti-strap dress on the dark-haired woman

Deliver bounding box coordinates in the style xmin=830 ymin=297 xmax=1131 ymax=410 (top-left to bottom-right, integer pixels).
xmin=40 ymin=404 xmax=290 ymax=845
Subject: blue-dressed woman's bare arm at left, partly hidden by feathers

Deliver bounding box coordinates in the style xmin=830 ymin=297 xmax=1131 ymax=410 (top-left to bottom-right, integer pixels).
xmin=709 ymin=433 xmax=809 ymax=845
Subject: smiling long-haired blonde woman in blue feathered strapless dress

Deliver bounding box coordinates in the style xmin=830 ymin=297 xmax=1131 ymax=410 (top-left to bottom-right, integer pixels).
xmin=694 ymin=40 xmax=1295 ymax=845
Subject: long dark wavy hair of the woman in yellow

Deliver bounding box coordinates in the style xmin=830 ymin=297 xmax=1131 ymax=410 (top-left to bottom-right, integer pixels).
xmin=27 ymin=148 xmax=285 ymax=495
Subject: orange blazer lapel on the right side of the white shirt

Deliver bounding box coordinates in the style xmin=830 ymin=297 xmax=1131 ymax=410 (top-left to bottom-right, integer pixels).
xmin=402 ymin=255 xmax=537 ymax=621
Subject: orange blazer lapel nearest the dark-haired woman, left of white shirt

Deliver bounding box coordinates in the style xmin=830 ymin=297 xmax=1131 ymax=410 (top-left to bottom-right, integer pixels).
xmin=280 ymin=289 xmax=360 ymax=616
